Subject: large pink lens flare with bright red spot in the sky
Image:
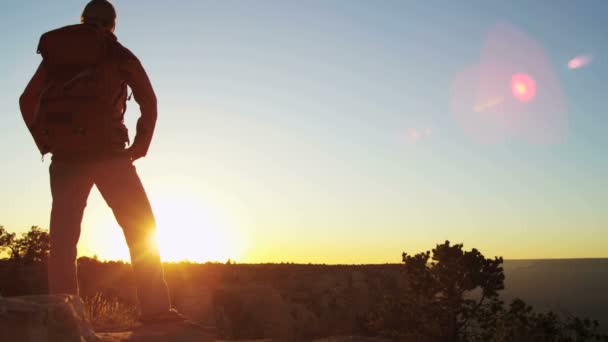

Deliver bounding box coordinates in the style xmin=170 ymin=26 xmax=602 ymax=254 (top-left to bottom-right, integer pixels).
xmin=450 ymin=22 xmax=568 ymax=144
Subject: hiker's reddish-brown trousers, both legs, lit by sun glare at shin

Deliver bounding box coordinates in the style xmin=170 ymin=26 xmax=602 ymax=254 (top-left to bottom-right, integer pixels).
xmin=49 ymin=156 xmax=170 ymax=315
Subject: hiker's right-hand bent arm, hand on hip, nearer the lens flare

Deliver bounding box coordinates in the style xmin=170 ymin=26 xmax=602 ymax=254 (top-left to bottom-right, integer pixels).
xmin=122 ymin=52 xmax=158 ymax=160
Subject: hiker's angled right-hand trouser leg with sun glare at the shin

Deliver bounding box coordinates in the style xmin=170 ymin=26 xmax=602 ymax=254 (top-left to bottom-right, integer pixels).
xmin=94 ymin=157 xmax=171 ymax=317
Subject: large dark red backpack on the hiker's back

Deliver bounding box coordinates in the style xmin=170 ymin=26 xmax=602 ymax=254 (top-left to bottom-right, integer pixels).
xmin=32 ymin=24 xmax=128 ymax=157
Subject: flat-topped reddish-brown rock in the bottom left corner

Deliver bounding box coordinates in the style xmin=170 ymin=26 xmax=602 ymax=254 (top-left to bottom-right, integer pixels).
xmin=0 ymin=295 xmax=101 ymax=342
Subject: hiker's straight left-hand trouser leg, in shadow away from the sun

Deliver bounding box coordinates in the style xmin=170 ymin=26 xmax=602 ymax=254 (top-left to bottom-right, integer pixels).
xmin=48 ymin=161 xmax=93 ymax=295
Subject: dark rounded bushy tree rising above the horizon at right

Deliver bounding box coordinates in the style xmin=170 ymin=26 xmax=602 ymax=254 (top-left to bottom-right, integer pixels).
xmin=403 ymin=241 xmax=505 ymax=342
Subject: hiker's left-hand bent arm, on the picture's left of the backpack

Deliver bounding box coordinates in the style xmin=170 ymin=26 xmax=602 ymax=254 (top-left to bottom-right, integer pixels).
xmin=19 ymin=63 xmax=49 ymax=155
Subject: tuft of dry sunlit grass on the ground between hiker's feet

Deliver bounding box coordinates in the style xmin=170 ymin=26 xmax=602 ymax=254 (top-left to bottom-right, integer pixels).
xmin=84 ymin=293 xmax=139 ymax=332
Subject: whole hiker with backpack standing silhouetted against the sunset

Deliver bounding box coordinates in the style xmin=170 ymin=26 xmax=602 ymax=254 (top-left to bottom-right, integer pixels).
xmin=19 ymin=0 xmax=186 ymax=323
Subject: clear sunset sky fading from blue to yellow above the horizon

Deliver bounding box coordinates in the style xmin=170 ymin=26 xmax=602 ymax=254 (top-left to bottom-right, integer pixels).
xmin=0 ymin=0 xmax=608 ymax=264
